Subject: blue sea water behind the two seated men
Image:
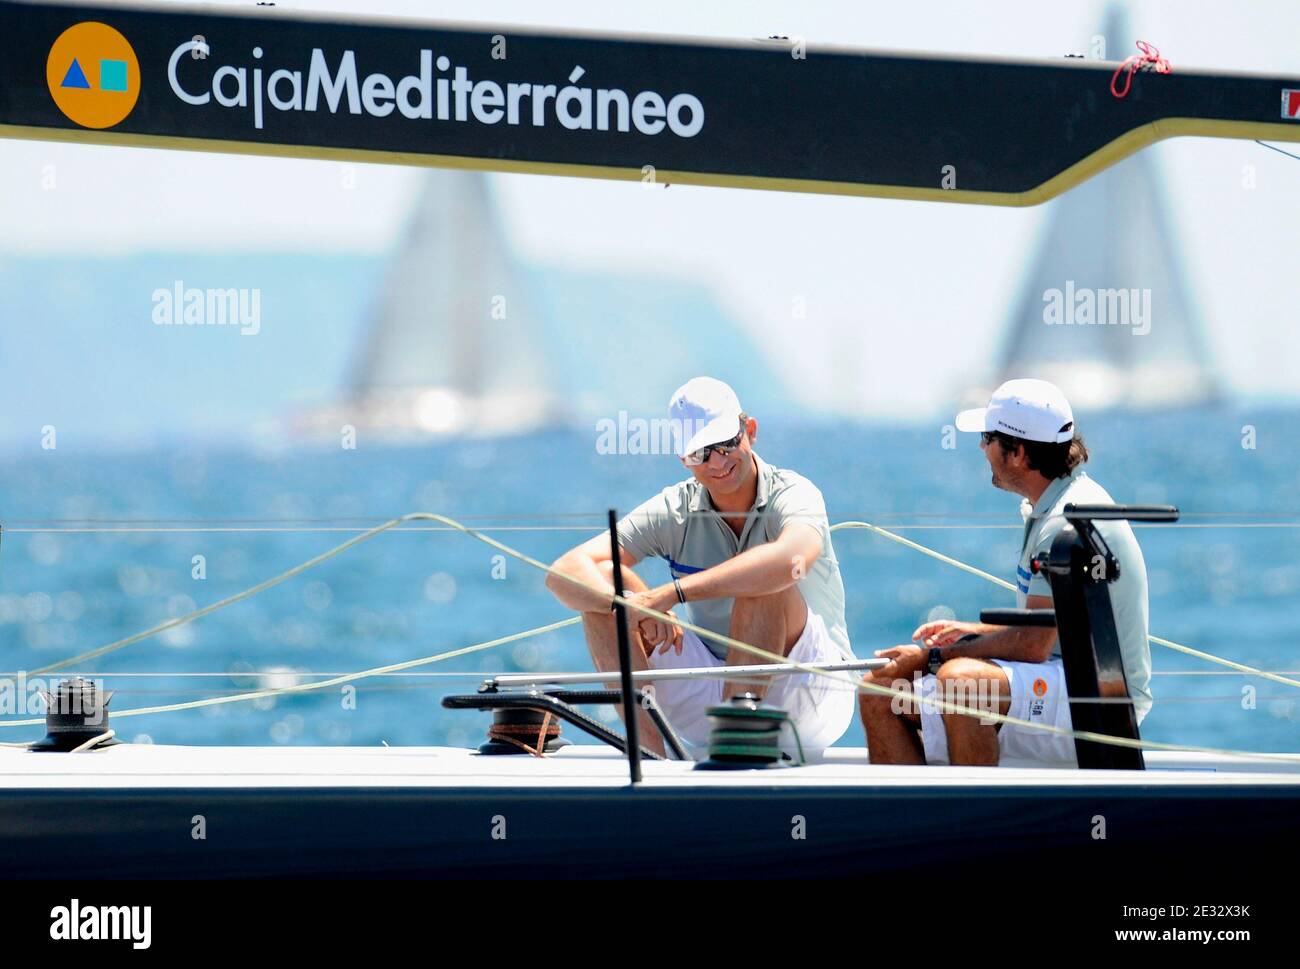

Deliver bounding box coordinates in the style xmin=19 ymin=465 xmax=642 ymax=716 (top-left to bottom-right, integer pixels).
xmin=0 ymin=410 xmax=1300 ymax=750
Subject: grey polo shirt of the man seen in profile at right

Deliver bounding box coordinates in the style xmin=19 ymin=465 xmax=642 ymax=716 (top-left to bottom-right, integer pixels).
xmin=1015 ymin=464 xmax=1152 ymax=723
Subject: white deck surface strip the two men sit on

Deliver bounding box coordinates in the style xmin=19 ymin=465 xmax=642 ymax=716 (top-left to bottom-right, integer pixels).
xmin=0 ymin=744 xmax=1300 ymax=796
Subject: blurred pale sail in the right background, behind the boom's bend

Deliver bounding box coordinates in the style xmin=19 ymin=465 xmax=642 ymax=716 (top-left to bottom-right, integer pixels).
xmin=997 ymin=8 xmax=1218 ymax=408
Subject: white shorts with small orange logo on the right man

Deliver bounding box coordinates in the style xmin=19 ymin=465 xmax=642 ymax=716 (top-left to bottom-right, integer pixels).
xmin=920 ymin=659 xmax=1079 ymax=767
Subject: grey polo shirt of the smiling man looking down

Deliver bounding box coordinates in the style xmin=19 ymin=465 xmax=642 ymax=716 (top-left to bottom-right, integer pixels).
xmin=619 ymin=454 xmax=854 ymax=659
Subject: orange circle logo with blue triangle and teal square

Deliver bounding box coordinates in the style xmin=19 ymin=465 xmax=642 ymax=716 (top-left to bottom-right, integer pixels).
xmin=46 ymin=21 xmax=140 ymax=127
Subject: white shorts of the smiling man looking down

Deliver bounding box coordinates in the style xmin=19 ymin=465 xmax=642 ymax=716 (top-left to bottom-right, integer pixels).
xmin=649 ymin=610 xmax=857 ymax=753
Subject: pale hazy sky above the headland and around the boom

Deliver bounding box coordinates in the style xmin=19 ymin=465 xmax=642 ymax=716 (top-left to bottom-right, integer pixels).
xmin=0 ymin=0 xmax=1300 ymax=416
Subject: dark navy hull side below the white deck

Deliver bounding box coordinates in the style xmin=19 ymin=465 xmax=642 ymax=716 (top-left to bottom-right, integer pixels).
xmin=0 ymin=784 xmax=1300 ymax=879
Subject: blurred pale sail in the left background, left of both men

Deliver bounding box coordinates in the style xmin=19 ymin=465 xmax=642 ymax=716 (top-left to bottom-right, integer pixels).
xmin=343 ymin=170 xmax=559 ymax=437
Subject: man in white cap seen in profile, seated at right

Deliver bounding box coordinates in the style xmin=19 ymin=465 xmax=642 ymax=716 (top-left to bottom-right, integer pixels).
xmin=859 ymin=380 xmax=1152 ymax=766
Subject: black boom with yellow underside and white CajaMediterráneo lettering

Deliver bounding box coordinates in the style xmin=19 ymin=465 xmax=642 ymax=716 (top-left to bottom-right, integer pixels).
xmin=0 ymin=0 xmax=1300 ymax=204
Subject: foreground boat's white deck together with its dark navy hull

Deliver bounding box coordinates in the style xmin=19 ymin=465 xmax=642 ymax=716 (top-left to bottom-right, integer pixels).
xmin=0 ymin=744 xmax=1300 ymax=878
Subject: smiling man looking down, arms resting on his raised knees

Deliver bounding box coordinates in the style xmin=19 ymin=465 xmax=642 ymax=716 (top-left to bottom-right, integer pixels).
xmin=546 ymin=377 xmax=854 ymax=750
